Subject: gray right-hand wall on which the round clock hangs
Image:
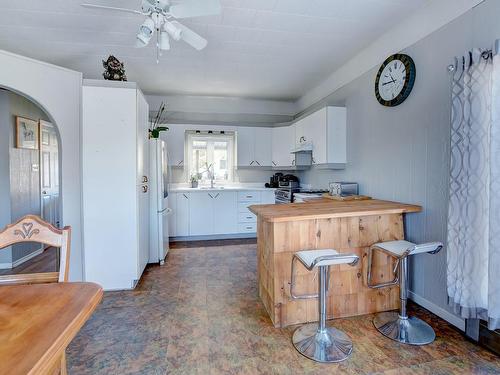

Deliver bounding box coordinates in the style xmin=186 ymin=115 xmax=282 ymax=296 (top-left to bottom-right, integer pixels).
xmin=301 ymin=0 xmax=500 ymax=324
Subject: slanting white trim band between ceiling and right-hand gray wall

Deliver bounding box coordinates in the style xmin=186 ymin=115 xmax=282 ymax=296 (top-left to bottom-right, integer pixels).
xmin=296 ymin=0 xmax=484 ymax=112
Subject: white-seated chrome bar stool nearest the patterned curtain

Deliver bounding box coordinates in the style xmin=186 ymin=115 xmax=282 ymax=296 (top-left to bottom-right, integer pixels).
xmin=367 ymin=241 xmax=443 ymax=345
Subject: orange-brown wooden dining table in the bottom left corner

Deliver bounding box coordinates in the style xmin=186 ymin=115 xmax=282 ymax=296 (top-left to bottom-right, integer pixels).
xmin=0 ymin=282 xmax=102 ymax=375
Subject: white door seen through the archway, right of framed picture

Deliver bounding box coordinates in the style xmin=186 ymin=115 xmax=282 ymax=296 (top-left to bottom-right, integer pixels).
xmin=40 ymin=120 xmax=60 ymax=227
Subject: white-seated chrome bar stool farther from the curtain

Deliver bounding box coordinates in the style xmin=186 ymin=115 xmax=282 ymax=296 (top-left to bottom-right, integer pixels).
xmin=290 ymin=249 xmax=359 ymax=363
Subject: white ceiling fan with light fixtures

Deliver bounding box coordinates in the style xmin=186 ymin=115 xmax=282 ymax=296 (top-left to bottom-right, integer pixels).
xmin=81 ymin=0 xmax=221 ymax=63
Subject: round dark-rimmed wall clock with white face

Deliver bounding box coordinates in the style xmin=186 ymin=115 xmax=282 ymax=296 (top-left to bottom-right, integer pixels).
xmin=375 ymin=53 xmax=416 ymax=107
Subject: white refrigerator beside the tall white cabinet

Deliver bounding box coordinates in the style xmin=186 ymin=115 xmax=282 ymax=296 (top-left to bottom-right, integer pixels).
xmin=149 ymin=139 xmax=171 ymax=265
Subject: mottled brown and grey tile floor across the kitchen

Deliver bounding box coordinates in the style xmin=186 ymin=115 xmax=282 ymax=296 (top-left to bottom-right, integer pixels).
xmin=68 ymin=242 xmax=500 ymax=375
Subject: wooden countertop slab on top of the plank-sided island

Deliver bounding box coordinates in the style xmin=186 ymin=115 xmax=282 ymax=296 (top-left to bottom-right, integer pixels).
xmin=248 ymin=199 xmax=422 ymax=222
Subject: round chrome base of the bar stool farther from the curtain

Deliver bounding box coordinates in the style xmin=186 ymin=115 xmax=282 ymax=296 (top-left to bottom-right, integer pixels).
xmin=292 ymin=323 xmax=352 ymax=363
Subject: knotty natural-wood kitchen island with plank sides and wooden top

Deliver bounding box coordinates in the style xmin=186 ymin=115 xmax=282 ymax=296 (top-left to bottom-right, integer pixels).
xmin=249 ymin=199 xmax=421 ymax=327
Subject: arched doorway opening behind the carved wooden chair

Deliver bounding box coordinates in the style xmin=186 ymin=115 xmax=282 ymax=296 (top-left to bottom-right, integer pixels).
xmin=0 ymin=88 xmax=62 ymax=274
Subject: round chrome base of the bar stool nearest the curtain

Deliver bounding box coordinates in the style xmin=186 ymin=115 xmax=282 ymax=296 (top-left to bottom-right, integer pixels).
xmin=373 ymin=312 xmax=436 ymax=345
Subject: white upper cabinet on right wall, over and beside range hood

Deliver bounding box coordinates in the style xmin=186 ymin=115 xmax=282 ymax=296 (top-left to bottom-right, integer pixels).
xmin=295 ymin=107 xmax=347 ymax=169
